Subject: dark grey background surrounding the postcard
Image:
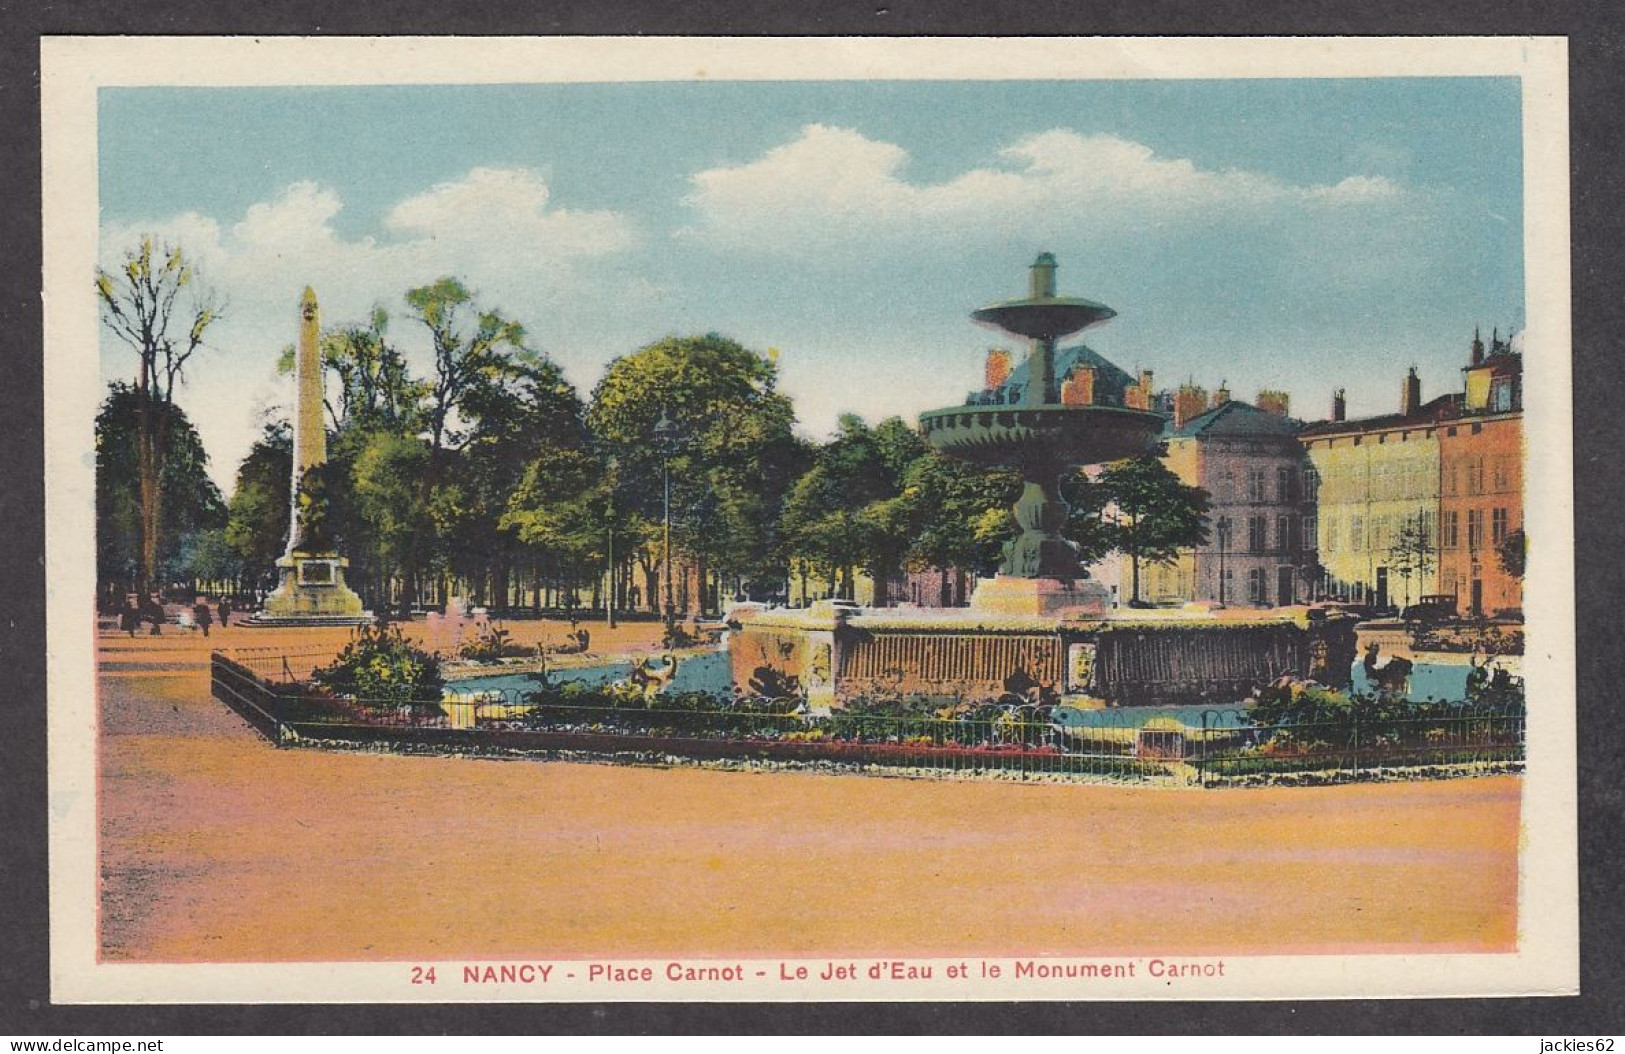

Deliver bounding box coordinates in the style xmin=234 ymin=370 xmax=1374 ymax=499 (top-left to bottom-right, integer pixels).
xmin=0 ymin=0 xmax=1625 ymax=1032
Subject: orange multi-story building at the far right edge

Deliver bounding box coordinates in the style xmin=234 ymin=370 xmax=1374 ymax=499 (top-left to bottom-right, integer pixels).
xmin=1438 ymin=333 xmax=1523 ymax=616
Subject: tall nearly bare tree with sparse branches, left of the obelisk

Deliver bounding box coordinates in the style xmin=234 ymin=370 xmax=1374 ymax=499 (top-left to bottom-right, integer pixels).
xmin=96 ymin=237 xmax=223 ymax=588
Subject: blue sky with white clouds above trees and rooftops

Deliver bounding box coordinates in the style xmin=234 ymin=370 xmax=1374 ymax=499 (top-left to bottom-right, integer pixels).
xmin=99 ymin=78 xmax=1524 ymax=494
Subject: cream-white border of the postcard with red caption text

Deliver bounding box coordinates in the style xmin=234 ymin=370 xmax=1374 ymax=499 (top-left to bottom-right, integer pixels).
xmin=41 ymin=37 xmax=1578 ymax=1004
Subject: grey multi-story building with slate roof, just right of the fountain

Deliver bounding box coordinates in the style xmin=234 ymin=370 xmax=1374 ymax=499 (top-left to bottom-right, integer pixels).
xmin=1141 ymin=385 xmax=1316 ymax=607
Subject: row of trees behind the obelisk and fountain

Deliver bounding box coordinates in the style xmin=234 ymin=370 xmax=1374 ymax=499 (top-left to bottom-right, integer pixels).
xmin=88 ymin=242 xmax=1206 ymax=611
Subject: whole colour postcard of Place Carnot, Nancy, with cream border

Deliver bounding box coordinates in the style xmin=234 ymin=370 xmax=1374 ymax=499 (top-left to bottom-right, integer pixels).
xmin=41 ymin=37 xmax=1578 ymax=1004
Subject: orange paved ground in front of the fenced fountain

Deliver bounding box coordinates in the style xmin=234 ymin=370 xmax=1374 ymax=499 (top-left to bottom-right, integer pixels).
xmin=101 ymin=624 xmax=1521 ymax=961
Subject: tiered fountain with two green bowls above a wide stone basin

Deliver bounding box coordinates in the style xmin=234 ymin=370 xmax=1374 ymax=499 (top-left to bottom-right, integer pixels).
xmin=730 ymin=253 xmax=1355 ymax=708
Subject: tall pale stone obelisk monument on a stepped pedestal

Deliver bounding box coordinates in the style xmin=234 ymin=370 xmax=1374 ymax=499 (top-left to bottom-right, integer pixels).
xmin=247 ymin=286 xmax=372 ymax=625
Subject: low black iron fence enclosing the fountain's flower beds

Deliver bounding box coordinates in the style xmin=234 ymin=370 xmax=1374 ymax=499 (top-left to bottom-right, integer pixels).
xmin=213 ymin=654 xmax=1524 ymax=786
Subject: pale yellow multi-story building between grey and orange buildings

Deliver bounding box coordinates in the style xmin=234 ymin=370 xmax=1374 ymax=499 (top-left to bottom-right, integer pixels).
xmin=1300 ymin=367 xmax=1461 ymax=607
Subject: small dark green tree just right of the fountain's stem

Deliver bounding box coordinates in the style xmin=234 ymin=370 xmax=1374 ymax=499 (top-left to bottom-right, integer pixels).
xmin=1092 ymin=456 xmax=1209 ymax=606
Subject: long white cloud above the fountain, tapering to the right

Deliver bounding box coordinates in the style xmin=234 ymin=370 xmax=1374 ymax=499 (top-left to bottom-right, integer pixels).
xmin=684 ymin=125 xmax=1402 ymax=252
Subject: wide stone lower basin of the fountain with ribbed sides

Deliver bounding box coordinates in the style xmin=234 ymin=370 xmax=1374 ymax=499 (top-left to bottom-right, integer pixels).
xmin=728 ymin=601 xmax=1355 ymax=708
